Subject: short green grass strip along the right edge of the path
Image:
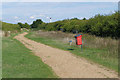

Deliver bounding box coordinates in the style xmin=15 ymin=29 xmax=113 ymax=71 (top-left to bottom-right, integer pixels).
xmin=26 ymin=32 xmax=118 ymax=71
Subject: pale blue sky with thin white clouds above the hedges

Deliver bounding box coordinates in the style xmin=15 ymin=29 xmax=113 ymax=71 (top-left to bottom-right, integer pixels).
xmin=2 ymin=2 xmax=118 ymax=24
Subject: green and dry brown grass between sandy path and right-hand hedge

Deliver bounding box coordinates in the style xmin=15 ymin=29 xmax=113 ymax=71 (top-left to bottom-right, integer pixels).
xmin=26 ymin=30 xmax=118 ymax=71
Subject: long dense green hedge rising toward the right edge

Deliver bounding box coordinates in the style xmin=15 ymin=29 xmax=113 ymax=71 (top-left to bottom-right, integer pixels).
xmin=31 ymin=12 xmax=120 ymax=38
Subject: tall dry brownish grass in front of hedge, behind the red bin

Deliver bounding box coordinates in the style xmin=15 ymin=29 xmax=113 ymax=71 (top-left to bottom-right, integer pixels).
xmin=36 ymin=30 xmax=118 ymax=57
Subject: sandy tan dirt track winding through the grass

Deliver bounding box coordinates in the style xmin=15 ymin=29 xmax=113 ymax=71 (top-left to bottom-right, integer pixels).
xmin=14 ymin=32 xmax=117 ymax=78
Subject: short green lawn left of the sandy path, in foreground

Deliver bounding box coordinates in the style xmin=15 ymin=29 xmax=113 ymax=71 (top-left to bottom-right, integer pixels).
xmin=2 ymin=34 xmax=57 ymax=78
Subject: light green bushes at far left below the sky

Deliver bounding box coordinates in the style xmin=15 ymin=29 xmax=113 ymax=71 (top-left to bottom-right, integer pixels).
xmin=2 ymin=22 xmax=20 ymax=31
